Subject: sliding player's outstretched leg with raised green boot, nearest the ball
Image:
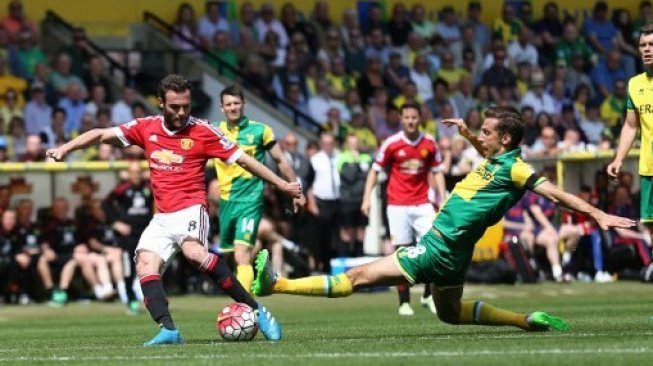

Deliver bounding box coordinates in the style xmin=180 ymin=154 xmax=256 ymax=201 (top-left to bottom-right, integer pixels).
xmin=252 ymin=249 xmax=408 ymax=297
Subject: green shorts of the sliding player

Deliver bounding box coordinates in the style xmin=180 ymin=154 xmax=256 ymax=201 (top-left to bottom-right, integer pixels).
xmin=394 ymin=229 xmax=474 ymax=287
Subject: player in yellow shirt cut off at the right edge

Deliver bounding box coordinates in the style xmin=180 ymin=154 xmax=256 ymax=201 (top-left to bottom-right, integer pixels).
xmin=607 ymin=24 xmax=653 ymax=246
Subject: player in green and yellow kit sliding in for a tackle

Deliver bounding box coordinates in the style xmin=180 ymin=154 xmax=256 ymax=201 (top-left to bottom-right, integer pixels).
xmin=253 ymin=107 xmax=635 ymax=331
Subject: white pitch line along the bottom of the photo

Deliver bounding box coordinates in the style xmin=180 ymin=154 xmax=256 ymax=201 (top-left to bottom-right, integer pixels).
xmin=0 ymin=348 xmax=653 ymax=362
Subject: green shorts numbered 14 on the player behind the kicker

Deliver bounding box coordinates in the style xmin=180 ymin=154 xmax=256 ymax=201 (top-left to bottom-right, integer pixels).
xmin=219 ymin=200 xmax=263 ymax=252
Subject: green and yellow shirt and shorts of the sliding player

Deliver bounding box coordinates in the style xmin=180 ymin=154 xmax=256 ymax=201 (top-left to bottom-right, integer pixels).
xmin=395 ymin=149 xmax=546 ymax=286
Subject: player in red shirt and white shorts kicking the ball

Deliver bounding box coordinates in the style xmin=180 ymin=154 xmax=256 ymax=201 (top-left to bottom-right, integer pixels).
xmin=47 ymin=75 xmax=301 ymax=346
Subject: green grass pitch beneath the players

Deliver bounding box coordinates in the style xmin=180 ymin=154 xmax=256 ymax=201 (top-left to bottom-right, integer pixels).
xmin=0 ymin=282 xmax=653 ymax=366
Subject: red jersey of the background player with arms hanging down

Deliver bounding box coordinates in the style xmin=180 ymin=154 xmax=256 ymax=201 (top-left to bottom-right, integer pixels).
xmin=373 ymin=131 xmax=442 ymax=206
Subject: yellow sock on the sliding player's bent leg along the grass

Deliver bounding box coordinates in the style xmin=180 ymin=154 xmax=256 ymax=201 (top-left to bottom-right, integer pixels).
xmin=460 ymin=301 xmax=530 ymax=329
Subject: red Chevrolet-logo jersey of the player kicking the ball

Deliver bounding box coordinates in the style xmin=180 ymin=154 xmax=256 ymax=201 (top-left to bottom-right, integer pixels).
xmin=114 ymin=116 xmax=243 ymax=213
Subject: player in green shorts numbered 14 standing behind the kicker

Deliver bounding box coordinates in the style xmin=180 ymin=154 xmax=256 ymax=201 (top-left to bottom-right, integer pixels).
xmin=214 ymin=85 xmax=306 ymax=290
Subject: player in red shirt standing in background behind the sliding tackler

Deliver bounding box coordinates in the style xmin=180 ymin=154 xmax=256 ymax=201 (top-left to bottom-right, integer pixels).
xmin=361 ymin=103 xmax=445 ymax=315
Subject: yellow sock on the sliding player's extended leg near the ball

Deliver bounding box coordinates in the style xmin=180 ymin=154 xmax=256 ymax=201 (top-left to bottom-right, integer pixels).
xmin=272 ymin=273 xmax=354 ymax=297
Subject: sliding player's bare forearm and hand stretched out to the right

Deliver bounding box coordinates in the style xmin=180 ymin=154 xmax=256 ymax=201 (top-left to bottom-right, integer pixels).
xmin=533 ymin=182 xmax=637 ymax=230
